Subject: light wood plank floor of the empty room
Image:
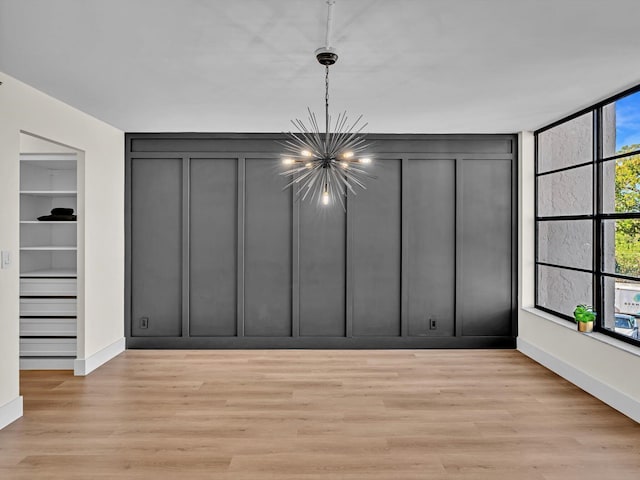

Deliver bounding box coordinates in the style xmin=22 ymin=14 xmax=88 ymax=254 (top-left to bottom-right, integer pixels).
xmin=0 ymin=350 xmax=640 ymax=480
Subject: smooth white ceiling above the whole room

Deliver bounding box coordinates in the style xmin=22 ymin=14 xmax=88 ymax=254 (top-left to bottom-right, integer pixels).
xmin=0 ymin=0 xmax=640 ymax=133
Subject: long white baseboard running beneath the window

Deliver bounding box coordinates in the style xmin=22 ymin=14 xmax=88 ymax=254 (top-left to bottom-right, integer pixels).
xmin=517 ymin=338 xmax=640 ymax=423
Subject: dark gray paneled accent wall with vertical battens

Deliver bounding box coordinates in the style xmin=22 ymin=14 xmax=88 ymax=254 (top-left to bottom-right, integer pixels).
xmin=125 ymin=134 xmax=517 ymax=348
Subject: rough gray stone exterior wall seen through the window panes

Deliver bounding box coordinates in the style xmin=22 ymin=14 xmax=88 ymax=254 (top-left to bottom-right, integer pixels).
xmin=538 ymin=105 xmax=616 ymax=328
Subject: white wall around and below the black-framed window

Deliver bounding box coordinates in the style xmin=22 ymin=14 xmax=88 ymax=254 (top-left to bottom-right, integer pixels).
xmin=518 ymin=132 xmax=640 ymax=422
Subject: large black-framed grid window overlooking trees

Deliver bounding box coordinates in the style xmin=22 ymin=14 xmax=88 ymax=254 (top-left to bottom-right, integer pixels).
xmin=535 ymin=82 xmax=640 ymax=345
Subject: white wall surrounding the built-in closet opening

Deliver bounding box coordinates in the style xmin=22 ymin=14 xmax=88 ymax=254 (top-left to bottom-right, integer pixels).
xmin=0 ymin=73 xmax=124 ymax=420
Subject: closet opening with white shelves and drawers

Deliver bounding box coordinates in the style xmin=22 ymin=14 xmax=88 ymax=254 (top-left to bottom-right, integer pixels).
xmin=19 ymin=132 xmax=84 ymax=370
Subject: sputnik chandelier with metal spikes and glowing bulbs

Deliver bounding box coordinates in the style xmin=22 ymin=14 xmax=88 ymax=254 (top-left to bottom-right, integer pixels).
xmin=280 ymin=0 xmax=375 ymax=210
